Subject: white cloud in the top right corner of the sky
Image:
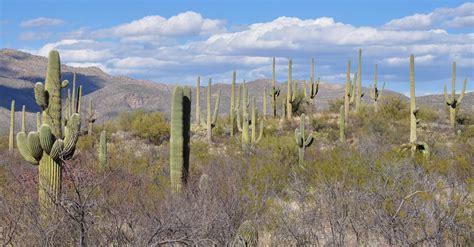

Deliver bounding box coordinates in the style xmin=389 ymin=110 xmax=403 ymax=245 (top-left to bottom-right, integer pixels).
xmin=383 ymin=3 xmax=474 ymax=30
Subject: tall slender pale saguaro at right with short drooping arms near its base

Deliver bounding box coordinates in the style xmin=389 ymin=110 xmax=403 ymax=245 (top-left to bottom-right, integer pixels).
xmin=401 ymin=54 xmax=430 ymax=156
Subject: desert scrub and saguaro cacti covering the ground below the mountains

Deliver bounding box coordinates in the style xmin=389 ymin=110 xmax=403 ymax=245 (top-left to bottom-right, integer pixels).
xmin=0 ymin=50 xmax=474 ymax=246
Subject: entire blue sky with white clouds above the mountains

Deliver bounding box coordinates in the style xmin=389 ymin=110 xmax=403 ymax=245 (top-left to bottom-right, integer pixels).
xmin=0 ymin=0 xmax=474 ymax=95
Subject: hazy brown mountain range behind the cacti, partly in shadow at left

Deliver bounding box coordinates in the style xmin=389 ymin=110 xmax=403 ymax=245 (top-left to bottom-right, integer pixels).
xmin=0 ymin=49 xmax=466 ymax=132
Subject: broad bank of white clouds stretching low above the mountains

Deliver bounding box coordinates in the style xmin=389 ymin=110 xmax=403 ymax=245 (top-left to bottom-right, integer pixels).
xmin=27 ymin=4 xmax=474 ymax=92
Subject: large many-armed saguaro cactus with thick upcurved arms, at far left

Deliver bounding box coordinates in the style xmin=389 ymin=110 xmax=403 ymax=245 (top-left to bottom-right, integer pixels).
xmin=16 ymin=50 xmax=81 ymax=215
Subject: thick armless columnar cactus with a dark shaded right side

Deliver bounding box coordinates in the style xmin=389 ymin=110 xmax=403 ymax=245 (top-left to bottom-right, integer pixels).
xmin=170 ymin=86 xmax=191 ymax=192
